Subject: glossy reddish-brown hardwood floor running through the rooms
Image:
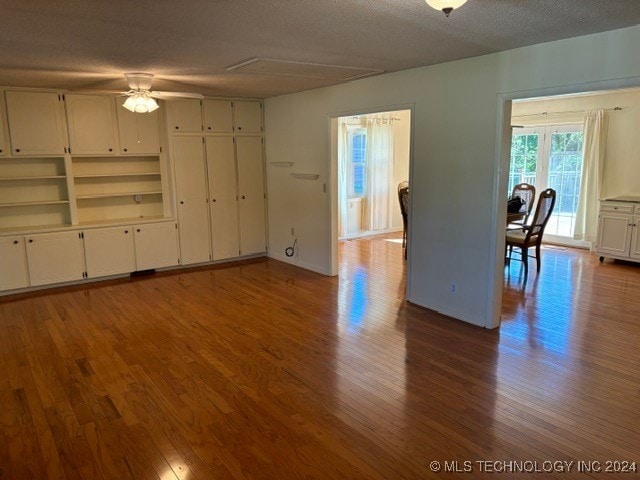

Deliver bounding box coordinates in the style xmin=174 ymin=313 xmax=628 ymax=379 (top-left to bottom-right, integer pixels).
xmin=0 ymin=236 xmax=640 ymax=480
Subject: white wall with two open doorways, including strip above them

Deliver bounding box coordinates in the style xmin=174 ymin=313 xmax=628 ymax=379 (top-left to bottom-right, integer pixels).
xmin=265 ymin=27 xmax=640 ymax=326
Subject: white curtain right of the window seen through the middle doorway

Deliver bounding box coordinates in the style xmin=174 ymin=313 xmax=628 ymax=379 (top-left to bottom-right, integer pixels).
xmin=362 ymin=122 xmax=393 ymax=231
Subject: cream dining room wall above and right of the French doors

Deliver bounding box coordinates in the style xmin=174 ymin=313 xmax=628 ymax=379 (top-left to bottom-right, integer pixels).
xmin=512 ymin=90 xmax=640 ymax=197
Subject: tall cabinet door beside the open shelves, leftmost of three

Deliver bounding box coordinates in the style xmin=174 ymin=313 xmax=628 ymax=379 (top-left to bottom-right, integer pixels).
xmin=173 ymin=136 xmax=211 ymax=265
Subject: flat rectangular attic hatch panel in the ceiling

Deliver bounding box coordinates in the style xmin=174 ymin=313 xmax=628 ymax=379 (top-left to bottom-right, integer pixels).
xmin=227 ymin=58 xmax=384 ymax=80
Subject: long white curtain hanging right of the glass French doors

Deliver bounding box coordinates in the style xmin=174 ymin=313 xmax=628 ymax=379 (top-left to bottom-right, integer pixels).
xmin=573 ymin=110 xmax=607 ymax=244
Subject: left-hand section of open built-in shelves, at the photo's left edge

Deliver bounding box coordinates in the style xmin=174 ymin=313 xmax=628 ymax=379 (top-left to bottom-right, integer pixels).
xmin=0 ymin=157 xmax=71 ymax=231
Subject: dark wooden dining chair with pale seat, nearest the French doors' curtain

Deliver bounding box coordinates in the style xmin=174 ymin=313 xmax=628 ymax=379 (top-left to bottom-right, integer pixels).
xmin=506 ymin=188 xmax=556 ymax=278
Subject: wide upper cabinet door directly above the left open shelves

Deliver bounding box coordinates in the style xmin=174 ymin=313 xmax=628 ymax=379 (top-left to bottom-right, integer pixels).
xmin=5 ymin=91 xmax=67 ymax=156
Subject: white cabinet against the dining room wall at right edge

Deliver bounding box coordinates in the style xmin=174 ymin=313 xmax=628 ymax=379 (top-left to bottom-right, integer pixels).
xmin=596 ymin=198 xmax=640 ymax=262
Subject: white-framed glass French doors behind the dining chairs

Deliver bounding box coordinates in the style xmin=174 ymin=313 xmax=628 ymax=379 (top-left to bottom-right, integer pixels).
xmin=509 ymin=125 xmax=583 ymax=245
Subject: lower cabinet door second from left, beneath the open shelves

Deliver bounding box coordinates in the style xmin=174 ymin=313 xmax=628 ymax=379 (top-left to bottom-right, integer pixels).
xmin=25 ymin=232 xmax=84 ymax=286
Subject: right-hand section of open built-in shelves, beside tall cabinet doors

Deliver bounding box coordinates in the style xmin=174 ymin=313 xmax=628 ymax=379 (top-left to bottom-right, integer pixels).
xmin=72 ymin=156 xmax=164 ymax=225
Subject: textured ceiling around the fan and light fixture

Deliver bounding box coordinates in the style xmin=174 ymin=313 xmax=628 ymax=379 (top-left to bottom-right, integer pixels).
xmin=0 ymin=0 xmax=640 ymax=97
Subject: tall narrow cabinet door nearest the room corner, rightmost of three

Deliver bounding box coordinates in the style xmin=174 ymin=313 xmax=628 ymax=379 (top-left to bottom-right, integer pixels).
xmin=236 ymin=137 xmax=267 ymax=255
